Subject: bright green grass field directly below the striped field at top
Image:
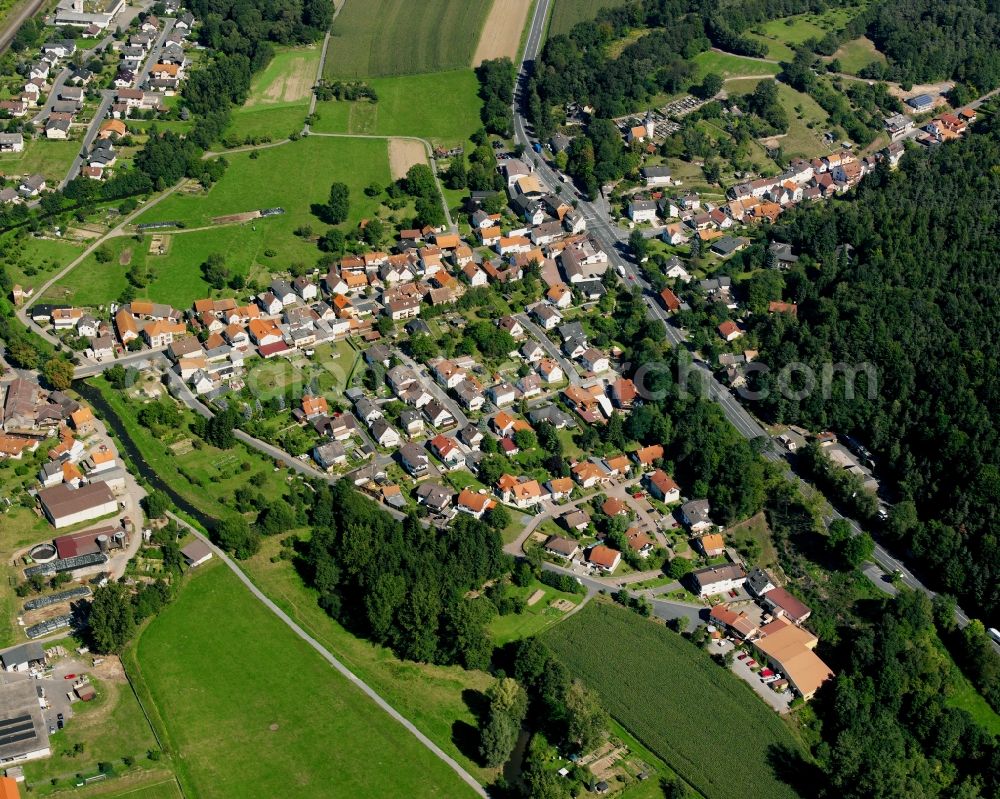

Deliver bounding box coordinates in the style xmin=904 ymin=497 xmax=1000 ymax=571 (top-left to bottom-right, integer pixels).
xmin=313 ymin=69 xmax=482 ymax=145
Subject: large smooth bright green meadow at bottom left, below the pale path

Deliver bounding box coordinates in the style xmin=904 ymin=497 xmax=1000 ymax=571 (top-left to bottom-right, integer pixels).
xmin=128 ymin=561 xmax=482 ymax=799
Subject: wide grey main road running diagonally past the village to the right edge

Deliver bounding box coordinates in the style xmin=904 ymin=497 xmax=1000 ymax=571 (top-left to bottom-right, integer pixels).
xmin=513 ymin=0 xmax=984 ymax=640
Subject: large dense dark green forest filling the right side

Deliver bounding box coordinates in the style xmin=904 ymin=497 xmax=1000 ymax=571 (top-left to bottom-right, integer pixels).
xmin=755 ymin=117 xmax=1000 ymax=617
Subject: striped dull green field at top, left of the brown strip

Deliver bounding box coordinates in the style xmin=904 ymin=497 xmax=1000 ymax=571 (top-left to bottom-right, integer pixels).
xmin=324 ymin=0 xmax=491 ymax=78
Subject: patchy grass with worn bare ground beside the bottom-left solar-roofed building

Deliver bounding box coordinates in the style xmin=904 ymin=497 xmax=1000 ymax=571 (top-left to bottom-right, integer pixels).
xmin=24 ymin=677 xmax=159 ymax=795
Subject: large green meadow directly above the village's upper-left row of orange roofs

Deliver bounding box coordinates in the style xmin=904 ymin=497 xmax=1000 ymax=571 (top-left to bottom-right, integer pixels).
xmin=55 ymin=137 xmax=390 ymax=308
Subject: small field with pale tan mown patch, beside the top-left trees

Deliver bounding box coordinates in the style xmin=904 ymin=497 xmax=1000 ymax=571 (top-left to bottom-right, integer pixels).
xmin=226 ymin=44 xmax=322 ymax=139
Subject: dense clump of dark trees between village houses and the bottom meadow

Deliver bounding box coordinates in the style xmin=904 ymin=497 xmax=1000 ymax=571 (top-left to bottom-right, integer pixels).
xmin=303 ymin=480 xmax=511 ymax=668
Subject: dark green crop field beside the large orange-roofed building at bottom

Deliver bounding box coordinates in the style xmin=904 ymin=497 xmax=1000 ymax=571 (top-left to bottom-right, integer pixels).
xmin=542 ymin=602 xmax=798 ymax=799
